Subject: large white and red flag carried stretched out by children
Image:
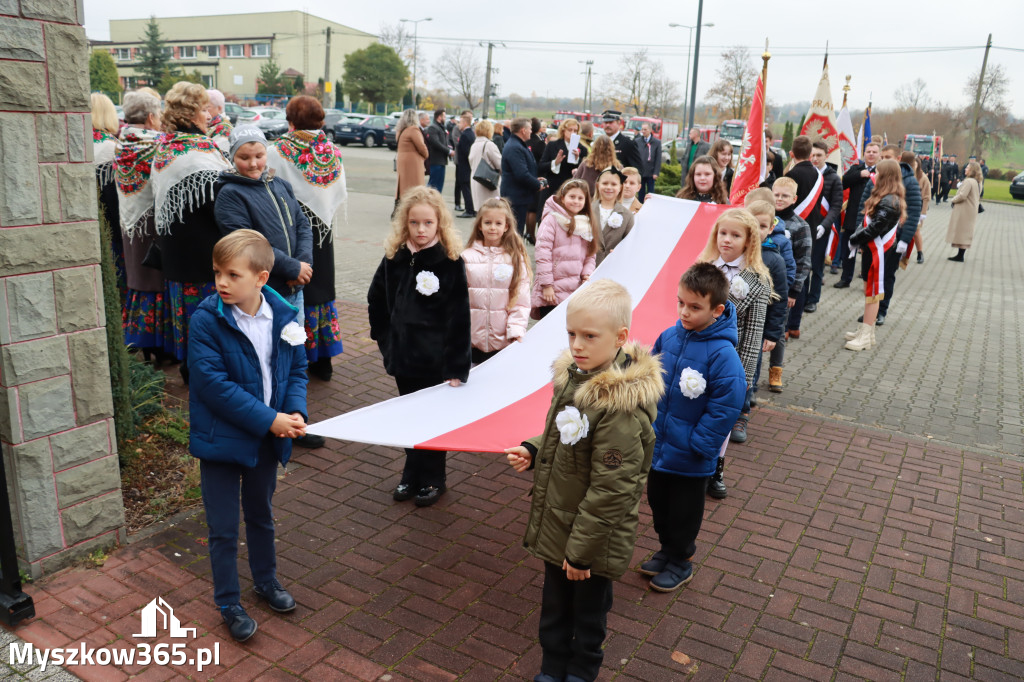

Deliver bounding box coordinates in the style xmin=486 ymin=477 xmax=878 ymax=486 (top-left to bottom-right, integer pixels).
xmin=307 ymin=195 xmax=729 ymax=453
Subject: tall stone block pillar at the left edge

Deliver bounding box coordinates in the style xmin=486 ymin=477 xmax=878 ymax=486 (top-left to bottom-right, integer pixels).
xmin=0 ymin=0 xmax=125 ymax=577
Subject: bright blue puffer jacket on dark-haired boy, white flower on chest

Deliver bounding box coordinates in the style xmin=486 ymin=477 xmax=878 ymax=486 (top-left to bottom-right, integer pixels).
xmin=651 ymin=301 xmax=746 ymax=476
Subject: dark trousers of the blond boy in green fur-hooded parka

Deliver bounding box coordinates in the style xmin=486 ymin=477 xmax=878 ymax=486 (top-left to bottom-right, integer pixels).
xmin=539 ymin=557 xmax=610 ymax=681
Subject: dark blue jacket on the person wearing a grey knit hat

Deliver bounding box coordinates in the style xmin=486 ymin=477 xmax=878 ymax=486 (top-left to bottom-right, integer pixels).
xmin=213 ymin=170 xmax=313 ymax=296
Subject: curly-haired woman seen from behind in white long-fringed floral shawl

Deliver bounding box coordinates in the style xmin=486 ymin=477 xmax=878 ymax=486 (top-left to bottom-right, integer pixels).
xmin=152 ymin=81 xmax=229 ymax=384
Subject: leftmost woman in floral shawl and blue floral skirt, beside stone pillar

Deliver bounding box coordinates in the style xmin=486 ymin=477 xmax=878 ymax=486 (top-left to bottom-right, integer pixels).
xmin=114 ymin=90 xmax=173 ymax=361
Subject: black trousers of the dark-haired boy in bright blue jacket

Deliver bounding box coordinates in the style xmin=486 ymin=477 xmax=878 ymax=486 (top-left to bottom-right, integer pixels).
xmin=647 ymin=469 xmax=711 ymax=564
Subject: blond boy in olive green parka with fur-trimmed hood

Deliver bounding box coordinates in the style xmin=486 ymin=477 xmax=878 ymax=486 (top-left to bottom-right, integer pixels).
xmin=505 ymin=280 xmax=665 ymax=682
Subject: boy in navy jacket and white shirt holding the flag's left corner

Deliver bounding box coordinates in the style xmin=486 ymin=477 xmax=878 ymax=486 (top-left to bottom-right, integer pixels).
xmin=188 ymin=229 xmax=306 ymax=642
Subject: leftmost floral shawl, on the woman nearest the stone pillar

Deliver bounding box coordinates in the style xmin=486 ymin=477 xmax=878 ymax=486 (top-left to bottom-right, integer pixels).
xmin=114 ymin=124 xmax=160 ymax=241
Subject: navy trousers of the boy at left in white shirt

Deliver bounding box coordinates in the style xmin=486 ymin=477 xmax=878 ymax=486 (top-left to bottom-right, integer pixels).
xmin=199 ymin=435 xmax=278 ymax=606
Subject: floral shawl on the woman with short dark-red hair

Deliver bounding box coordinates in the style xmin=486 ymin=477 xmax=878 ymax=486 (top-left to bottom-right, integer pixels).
xmin=266 ymin=130 xmax=348 ymax=247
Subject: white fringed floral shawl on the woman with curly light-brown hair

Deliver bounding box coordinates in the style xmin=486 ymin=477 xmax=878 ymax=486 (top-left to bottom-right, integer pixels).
xmin=153 ymin=128 xmax=230 ymax=235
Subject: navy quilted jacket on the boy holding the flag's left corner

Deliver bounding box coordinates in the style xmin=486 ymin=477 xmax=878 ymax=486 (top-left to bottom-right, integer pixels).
xmin=188 ymin=287 xmax=307 ymax=467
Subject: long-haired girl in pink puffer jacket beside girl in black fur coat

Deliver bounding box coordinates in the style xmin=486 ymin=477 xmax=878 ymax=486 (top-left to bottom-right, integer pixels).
xmin=462 ymin=199 xmax=529 ymax=365
